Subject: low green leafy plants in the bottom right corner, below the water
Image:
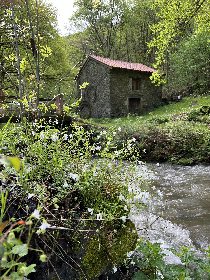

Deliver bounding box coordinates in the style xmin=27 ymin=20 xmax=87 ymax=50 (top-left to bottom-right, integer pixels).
xmin=132 ymin=239 xmax=210 ymax=280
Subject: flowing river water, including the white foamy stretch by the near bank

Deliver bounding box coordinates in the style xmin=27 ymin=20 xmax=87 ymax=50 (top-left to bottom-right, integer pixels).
xmin=131 ymin=164 xmax=210 ymax=252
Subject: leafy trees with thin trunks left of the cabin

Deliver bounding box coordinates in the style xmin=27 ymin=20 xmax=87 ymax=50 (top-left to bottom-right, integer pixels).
xmin=0 ymin=0 xmax=75 ymax=114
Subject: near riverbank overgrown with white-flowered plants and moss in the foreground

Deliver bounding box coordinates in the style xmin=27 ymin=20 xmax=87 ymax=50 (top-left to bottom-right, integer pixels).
xmin=0 ymin=119 xmax=209 ymax=280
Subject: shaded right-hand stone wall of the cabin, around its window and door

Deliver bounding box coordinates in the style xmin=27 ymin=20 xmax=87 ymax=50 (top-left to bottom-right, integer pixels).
xmin=110 ymin=69 xmax=161 ymax=117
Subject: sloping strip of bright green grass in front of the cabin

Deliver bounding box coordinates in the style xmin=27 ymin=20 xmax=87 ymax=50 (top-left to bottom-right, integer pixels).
xmin=90 ymin=95 xmax=210 ymax=128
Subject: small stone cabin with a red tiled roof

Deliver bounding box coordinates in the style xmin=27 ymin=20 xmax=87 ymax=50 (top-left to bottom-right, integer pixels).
xmin=76 ymin=55 xmax=162 ymax=118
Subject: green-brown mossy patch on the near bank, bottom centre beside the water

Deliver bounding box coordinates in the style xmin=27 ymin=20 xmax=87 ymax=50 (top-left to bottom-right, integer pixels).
xmin=82 ymin=220 xmax=138 ymax=280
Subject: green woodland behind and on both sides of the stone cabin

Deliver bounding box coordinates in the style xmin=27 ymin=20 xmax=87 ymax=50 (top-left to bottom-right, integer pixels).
xmin=0 ymin=0 xmax=210 ymax=109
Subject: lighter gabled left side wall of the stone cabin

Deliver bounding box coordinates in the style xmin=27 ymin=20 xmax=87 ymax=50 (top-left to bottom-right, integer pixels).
xmin=77 ymin=59 xmax=111 ymax=118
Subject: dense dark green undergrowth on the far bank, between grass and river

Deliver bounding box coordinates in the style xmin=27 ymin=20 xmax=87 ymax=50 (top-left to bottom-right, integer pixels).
xmin=111 ymin=121 xmax=210 ymax=164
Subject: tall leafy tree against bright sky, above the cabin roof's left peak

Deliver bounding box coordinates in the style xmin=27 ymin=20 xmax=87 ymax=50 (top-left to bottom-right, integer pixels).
xmin=72 ymin=0 xmax=124 ymax=57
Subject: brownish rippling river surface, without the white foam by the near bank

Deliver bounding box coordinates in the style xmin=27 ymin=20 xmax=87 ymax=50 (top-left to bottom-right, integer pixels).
xmin=139 ymin=164 xmax=210 ymax=245
